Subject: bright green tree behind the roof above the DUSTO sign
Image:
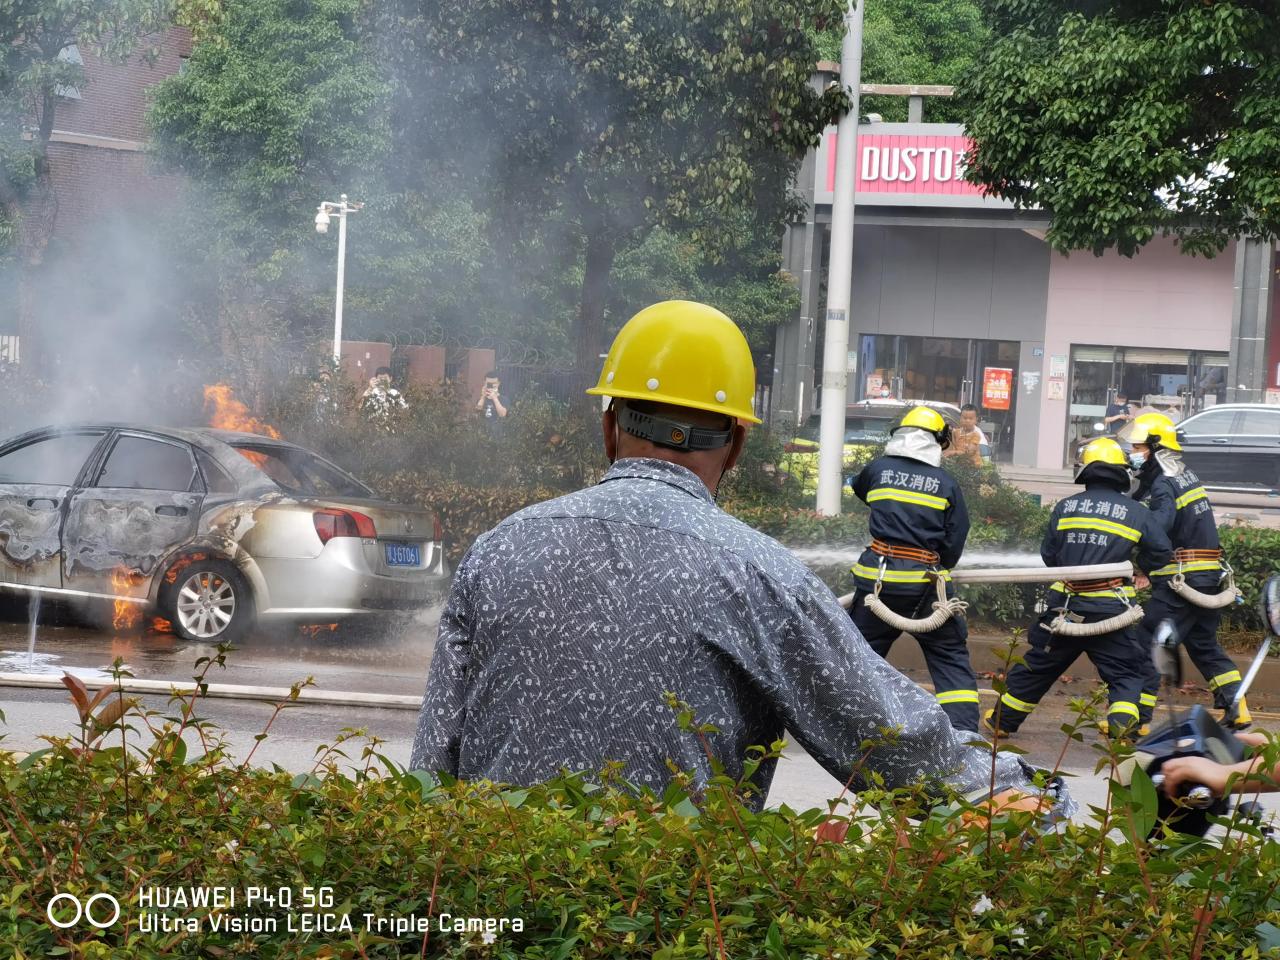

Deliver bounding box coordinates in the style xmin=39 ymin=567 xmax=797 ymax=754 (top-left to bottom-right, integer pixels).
xmin=818 ymin=0 xmax=989 ymax=122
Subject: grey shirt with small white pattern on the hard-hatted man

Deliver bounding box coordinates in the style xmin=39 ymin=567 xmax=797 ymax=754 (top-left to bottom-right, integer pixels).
xmin=410 ymin=460 xmax=1049 ymax=808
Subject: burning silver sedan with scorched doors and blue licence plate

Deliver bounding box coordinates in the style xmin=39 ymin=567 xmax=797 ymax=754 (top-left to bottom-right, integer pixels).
xmin=0 ymin=424 xmax=448 ymax=641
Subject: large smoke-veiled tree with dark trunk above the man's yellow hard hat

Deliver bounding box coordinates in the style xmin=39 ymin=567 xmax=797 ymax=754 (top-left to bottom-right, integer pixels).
xmin=380 ymin=0 xmax=844 ymax=391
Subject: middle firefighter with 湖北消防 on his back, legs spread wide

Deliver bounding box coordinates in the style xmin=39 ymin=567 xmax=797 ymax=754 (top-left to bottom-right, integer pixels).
xmin=983 ymin=436 xmax=1172 ymax=736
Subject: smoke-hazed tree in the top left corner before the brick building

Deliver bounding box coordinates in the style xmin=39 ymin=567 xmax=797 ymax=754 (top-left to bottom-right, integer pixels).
xmin=0 ymin=0 xmax=218 ymax=366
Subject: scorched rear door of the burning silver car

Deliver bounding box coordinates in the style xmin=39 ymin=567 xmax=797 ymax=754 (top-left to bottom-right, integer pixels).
xmin=61 ymin=428 xmax=207 ymax=599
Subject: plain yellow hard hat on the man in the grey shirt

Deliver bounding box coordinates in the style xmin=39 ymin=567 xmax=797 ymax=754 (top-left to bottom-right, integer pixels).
xmin=588 ymin=300 xmax=760 ymax=424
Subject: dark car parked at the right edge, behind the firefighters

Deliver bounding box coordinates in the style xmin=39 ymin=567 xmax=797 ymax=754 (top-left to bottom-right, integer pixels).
xmin=1178 ymin=403 xmax=1280 ymax=493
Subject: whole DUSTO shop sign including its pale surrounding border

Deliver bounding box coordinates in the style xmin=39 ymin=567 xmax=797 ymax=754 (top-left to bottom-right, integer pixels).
xmin=815 ymin=124 xmax=1006 ymax=206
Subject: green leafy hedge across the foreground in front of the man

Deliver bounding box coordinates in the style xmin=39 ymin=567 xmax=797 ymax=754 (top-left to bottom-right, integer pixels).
xmin=0 ymin=675 xmax=1280 ymax=960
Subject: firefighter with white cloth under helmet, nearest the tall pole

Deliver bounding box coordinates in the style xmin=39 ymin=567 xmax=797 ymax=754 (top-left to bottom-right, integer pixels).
xmin=850 ymin=407 xmax=978 ymax=732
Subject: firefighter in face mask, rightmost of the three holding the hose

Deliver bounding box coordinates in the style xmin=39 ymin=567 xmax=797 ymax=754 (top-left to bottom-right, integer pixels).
xmin=1129 ymin=413 xmax=1253 ymax=730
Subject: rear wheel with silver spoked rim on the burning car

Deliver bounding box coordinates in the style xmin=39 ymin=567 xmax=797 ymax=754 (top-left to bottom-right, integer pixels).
xmin=159 ymin=559 xmax=253 ymax=643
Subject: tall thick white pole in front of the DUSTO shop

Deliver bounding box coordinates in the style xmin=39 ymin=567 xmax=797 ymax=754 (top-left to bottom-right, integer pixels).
xmin=817 ymin=0 xmax=867 ymax=516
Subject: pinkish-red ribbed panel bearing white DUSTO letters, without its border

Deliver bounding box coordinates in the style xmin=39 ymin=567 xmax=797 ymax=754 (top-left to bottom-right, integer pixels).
xmin=827 ymin=133 xmax=982 ymax=197
